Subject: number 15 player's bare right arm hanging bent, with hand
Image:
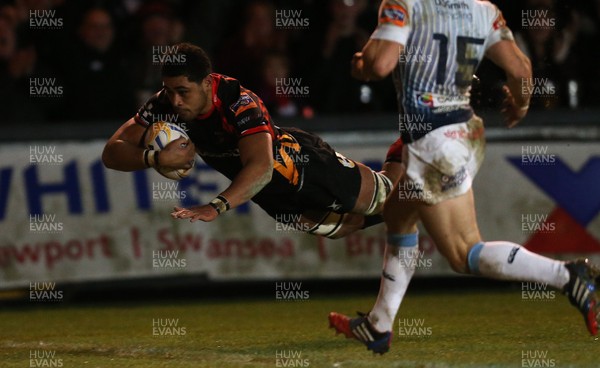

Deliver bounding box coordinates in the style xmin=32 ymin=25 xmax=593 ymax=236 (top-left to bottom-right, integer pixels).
xmin=486 ymin=40 xmax=532 ymax=128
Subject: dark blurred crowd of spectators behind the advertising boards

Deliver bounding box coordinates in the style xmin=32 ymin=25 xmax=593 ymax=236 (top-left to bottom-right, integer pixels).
xmin=0 ymin=0 xmax=600 ymax=122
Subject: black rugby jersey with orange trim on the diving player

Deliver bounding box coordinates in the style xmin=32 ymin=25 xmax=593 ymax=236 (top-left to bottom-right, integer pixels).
xmin=135 ymin=73 xmax=302 ymax=196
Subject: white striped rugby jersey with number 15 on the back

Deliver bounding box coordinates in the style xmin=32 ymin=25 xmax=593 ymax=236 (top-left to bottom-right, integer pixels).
xmin=371 ymin=0 xmax=513 ymax=141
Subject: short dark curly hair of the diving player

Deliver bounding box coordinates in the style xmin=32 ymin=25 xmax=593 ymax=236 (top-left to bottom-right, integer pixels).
xmin=161 ymin=43 xmax=212 ymax=83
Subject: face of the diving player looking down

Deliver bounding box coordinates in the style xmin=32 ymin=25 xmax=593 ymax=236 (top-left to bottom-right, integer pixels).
xmin=163 ymin=76 xmax=212 ymax=121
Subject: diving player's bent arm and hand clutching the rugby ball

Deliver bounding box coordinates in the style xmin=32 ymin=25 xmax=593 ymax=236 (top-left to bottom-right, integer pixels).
xmin=102 ymin=118 xmax=195 ymax=171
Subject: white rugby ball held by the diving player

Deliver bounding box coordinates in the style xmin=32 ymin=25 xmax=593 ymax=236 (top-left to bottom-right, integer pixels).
xmin=145 ymin=121 xmax=194 ymax=180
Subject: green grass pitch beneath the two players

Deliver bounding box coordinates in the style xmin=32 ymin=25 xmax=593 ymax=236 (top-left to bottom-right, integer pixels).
xmin=0 ymin=290 xmax=600 ymax=368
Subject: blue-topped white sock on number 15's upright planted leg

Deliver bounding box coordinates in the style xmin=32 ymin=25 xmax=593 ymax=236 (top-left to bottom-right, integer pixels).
xmin=369 ymin=232 xmax=419 ymax=332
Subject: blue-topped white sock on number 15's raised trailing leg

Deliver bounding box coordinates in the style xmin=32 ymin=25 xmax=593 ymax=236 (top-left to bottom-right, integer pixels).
xmin=468 ymin=241 xmax=569 ymax=290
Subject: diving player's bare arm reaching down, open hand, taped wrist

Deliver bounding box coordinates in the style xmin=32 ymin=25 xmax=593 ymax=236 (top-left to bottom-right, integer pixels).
xmin=171 ymin=133 xmax=273 ymax=222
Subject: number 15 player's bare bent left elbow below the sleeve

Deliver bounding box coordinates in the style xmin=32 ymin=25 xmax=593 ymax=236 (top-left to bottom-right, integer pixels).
xmin=352 ymin=39 xmax=404 ymax=81
